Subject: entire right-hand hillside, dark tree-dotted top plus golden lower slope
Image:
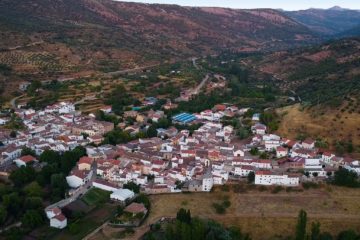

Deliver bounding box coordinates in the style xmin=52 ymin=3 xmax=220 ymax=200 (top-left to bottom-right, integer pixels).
xmin=247 ymin=38 xmax=360 ymax=153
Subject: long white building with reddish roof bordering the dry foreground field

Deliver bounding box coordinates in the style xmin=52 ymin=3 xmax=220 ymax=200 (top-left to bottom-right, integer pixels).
xmin=255 ymin=171 xmax=300 ymax=186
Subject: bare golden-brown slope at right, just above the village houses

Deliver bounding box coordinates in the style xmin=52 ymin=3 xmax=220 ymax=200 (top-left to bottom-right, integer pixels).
xmin=277 ymin=104 xmax=360 ymax=156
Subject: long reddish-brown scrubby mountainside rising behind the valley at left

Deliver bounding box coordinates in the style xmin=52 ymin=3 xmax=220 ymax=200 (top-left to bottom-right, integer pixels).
xmin=0 ymin=0 xmax=317 ymax=99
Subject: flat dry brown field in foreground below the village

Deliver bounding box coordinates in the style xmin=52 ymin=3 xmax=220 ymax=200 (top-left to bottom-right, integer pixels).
xmin=91 ymin=187 xmax=360 ymax=240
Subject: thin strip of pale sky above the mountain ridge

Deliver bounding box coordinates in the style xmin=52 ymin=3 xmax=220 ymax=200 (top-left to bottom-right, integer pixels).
xmin=116 ymin=0 xmax=360 ymax=10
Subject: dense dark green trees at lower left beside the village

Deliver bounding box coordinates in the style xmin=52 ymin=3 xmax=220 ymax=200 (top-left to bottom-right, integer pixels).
xmin=0 ymin=147 xmax=86 ymax=239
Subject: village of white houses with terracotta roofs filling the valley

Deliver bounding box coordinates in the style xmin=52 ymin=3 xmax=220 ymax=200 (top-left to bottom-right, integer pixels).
xmin=0 ymin=93 xmax=360 ymax=229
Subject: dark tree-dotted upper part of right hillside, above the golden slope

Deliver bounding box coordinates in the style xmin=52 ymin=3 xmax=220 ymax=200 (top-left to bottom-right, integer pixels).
xmin=250 ymin=38 xmax=360 ymax=106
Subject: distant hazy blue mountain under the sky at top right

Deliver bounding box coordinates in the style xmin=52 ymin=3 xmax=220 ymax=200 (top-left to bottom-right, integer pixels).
xmin=285 ymin=7 xmax=360 ymax=35
